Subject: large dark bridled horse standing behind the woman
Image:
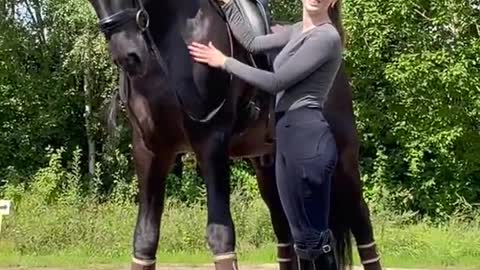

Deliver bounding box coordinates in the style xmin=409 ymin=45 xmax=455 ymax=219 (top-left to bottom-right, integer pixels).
xmin=90 ymin=0 xmax=381 ymax=270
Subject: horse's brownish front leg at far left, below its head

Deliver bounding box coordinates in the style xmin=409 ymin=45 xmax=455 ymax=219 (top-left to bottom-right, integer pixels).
xmin=131 ymin=134 xmax=175 ymax=270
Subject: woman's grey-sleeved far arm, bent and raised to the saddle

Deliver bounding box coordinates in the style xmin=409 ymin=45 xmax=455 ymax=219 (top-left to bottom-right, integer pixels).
xmin=222 ymin=0 xmax=293 ymax=53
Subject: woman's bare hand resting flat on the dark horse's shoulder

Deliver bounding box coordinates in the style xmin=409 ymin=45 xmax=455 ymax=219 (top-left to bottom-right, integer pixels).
xmin=188 ymin=42 xmax=227 ymax=68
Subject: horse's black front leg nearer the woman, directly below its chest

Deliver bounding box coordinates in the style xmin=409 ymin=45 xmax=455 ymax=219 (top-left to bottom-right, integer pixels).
xmin=194 ymin=131 xmax=237 ymax=270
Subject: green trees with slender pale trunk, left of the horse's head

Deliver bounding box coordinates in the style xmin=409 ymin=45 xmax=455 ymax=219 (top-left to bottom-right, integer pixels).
xmin=0 ymin=0 xmax=128 ymax=192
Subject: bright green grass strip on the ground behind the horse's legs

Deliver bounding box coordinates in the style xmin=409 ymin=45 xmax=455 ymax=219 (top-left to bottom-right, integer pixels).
xmin=0 ymin=196 xmax=480 ymax=269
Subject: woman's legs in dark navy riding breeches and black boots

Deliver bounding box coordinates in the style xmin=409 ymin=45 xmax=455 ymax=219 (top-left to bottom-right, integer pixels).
xmin=277 ymin=108 xmax=337 ymax=270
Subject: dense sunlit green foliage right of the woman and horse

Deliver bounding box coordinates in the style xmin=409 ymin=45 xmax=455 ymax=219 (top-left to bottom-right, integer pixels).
xmin=344 ymin=0 xmax=480 ymax=215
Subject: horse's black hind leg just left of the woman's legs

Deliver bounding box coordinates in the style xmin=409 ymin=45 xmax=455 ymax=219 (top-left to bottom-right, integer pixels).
xmin=251 ymin=158 xmax=297 ymax=270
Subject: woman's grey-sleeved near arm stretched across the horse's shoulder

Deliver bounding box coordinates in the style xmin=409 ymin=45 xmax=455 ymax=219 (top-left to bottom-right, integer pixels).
xmin=224 ymin=28 xmax=341 ymax=94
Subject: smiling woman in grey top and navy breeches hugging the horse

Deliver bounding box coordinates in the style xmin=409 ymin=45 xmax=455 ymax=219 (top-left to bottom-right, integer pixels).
xmin=189 ymin=0 xmax=343 ymax=270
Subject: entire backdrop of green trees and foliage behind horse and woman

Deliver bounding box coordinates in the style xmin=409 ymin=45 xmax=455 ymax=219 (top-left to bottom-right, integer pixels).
xmin=0 ymin=0 xmax=480 ymax=220
